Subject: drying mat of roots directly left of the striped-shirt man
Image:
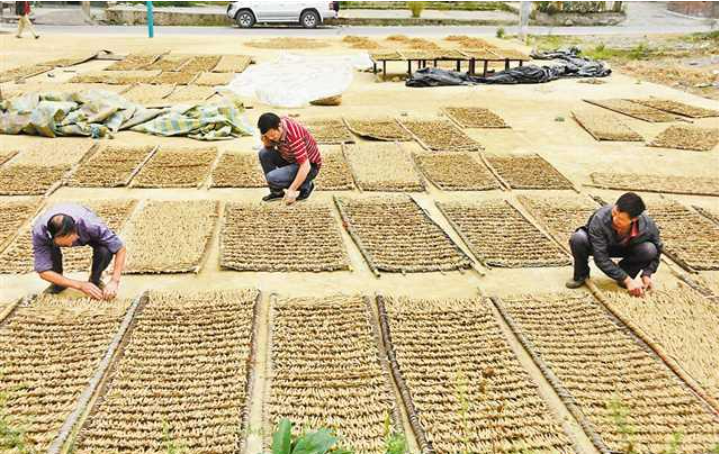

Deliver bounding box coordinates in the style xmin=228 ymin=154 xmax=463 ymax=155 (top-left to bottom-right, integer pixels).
xmin=212 ymin=152 xmax=268 ymax=188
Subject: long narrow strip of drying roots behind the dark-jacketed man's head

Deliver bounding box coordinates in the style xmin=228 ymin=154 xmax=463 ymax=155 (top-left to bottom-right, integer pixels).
xmin=590 ymin=172 xmax=719 ymax=196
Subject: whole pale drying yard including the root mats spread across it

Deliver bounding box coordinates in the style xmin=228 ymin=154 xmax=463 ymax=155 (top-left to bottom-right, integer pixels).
xmin=0 ymin=31 xmax=719 ymax=454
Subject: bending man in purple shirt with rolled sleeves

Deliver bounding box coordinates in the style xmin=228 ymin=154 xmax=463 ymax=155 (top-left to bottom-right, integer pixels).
xmin=32 ymin=203 xmax=126 ymax=300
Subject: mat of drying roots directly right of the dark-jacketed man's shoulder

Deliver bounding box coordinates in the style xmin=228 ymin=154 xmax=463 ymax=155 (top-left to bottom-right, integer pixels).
xmin=647 ymin=200 xmax=719 ymax=270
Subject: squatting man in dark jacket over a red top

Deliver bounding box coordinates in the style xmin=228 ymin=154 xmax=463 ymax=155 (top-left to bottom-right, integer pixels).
xmin=567 ymin=192 xmax=663 ymax=296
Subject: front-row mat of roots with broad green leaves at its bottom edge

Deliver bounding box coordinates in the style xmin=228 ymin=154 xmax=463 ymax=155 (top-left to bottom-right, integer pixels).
xmin=265 ymin=296 xmax=401 ymax=454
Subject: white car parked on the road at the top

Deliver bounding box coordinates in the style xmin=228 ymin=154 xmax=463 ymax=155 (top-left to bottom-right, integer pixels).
xmin=227 ymin=1 xmax=340 ymax=28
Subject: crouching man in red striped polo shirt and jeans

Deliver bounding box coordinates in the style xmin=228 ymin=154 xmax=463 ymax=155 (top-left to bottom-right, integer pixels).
xmin=257 ymin=112 xmax=322 ymax=205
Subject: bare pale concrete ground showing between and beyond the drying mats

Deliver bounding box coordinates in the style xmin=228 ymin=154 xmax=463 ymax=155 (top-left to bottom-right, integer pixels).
xmin=0 ymin=31 xmax=719 ymax=454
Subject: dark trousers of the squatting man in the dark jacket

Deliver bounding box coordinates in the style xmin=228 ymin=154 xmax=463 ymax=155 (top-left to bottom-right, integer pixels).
xmin=569 ymin=229 xmax=657 ymax=281
